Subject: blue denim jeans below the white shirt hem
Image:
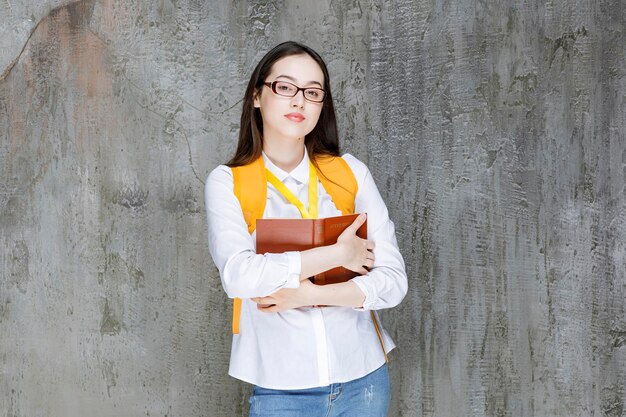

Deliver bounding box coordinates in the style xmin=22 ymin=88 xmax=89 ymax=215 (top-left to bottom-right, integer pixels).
xmin=250 ymin=364 xmax=389 ymax=417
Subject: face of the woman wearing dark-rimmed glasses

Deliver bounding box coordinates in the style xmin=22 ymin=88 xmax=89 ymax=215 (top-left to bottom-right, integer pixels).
xmin=254 ymin=54 xmax=324 ymax=145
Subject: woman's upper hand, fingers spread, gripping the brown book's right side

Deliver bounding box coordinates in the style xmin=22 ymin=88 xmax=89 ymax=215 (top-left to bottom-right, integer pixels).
xmin=335 ymin=213 xmax=374 ymax=275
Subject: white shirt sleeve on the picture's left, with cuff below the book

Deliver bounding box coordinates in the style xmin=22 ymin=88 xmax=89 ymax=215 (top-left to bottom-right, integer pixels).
xmin=204 ymin=165 xmax=301 ymax=298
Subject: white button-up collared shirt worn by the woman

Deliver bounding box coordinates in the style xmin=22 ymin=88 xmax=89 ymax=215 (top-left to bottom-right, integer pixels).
xmin=205 ymin=151 xmax=407 ymax=389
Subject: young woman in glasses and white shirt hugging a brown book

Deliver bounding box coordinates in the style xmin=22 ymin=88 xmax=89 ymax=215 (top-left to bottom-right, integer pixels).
xmin=205 ymin=42 xmax=407 ymax=417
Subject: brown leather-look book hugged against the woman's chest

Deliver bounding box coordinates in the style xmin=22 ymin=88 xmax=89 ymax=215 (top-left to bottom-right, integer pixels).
xmin=256 ymin=214 xmax=367 ymax=285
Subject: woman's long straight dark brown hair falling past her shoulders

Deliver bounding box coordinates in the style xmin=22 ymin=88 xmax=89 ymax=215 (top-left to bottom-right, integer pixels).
xmin=226 ymin=41 xmax=339 ymax=168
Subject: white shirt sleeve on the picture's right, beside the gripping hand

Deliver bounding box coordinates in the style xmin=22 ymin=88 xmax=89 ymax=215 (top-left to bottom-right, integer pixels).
xmin=343 ymin=154 xmax=408 ymax=310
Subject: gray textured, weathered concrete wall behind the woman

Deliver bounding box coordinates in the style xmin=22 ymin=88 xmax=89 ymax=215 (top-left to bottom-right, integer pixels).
xmin=0 ymin=0 xmax=626 ymax=417
